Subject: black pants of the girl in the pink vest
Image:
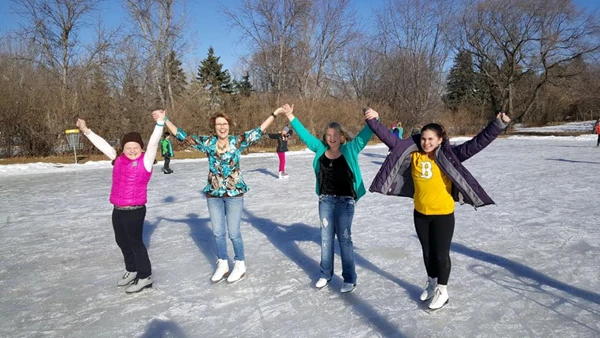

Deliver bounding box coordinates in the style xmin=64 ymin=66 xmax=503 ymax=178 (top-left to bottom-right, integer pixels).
xmin=112 ymin=206 xmax=152 ymax=278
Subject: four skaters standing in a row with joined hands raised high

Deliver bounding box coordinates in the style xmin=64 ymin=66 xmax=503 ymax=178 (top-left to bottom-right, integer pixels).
xmin=72 ymin=104 xmax=510 ymax=310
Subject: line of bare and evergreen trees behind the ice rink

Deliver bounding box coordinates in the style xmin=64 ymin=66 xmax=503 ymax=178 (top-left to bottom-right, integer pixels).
xmin=0 ymin=0 xmax=600 ymax=157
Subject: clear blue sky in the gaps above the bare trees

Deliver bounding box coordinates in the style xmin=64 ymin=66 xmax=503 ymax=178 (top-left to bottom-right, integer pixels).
xmin=0 ymin=0 xmax=600 ymax=75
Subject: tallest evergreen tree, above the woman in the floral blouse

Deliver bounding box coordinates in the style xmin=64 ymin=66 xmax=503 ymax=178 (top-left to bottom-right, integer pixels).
xmin=196 ymin=46 xmax=234 ymax=104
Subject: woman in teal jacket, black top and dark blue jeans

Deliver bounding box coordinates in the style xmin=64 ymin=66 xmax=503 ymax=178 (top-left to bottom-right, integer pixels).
xmin=282 ymin=104 xmax=373 ymax=293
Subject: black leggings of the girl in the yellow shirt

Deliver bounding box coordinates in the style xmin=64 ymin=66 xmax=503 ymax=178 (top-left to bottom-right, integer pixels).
xmin=414 ymin=210 xmax=454 ymax=285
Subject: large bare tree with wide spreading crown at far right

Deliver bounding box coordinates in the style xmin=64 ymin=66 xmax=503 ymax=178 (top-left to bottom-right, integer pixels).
xmin=460 ymin=0 xmax=600 ymax=121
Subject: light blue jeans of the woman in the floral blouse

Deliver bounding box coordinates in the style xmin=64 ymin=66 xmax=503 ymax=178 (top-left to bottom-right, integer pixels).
xmin=206 ymin=196 xmax=244 ymax=261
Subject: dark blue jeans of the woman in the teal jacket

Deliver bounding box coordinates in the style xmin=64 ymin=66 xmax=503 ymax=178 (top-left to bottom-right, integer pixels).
xmin=319 ymin=195 xmax=356 ymax=284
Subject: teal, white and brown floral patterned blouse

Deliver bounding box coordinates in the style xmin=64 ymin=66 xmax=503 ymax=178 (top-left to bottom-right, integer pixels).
xmin=176 ymin=127 xmax=263 ymax=197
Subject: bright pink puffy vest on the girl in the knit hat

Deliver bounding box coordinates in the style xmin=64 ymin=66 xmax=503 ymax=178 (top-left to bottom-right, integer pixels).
xmin=110 ymin=152 xmax=152 ymax=207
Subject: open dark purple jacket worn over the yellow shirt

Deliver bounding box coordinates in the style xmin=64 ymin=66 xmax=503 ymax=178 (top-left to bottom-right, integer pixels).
xmin=367 ymin=119 xmax=507 ymax=207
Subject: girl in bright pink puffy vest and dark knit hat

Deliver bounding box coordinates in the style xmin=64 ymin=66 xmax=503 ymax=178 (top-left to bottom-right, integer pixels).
xmin=77 ymin=111 xmax=164 ymax=293
